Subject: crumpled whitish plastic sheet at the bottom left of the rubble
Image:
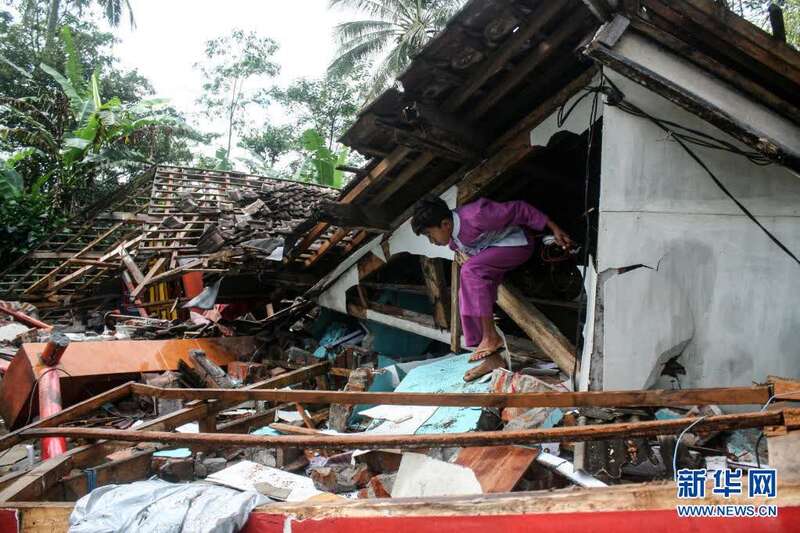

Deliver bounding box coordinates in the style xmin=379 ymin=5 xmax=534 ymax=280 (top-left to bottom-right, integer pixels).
xmin=69 ymin=480 xmax=270 ymax=533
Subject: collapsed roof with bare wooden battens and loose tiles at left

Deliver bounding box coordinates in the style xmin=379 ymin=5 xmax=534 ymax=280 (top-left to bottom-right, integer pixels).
xmin=0 ymin=166 xmax=338 ymax=311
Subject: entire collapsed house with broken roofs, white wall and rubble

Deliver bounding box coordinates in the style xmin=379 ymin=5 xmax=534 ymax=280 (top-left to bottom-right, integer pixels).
xmin=0 ymin=0 xmax=800 ymax=531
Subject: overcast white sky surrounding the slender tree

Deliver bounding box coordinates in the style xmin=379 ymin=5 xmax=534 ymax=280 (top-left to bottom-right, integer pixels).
xmin=106 ymin=0 xmax=352 ymax=162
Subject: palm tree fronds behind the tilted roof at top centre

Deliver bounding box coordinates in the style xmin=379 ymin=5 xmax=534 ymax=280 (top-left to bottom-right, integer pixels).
xmin=328 ymin=0 xmax=465 ymax=99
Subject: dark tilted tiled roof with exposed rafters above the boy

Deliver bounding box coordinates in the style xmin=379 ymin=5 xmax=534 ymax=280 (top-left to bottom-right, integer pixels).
xmin=289 ymin=0 xmax=800 ymax=274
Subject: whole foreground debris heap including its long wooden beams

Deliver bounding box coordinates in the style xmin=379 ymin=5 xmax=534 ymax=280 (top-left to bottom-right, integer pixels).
xmin=0 ymin=296 xmax=800 ymax=508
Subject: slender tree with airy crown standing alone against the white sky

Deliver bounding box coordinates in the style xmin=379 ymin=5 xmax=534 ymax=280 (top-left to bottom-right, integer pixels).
xmin=195 ymin=30 xmax=279 ymax=158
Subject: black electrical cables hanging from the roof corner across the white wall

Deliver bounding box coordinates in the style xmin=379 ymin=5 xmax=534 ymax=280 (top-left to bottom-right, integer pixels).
xmin=604 ymin=77 xmax=800 ymax=265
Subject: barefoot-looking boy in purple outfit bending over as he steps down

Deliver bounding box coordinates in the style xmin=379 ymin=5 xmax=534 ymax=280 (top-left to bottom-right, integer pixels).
xmin=411 ymin=196 xmax=573 ymax=381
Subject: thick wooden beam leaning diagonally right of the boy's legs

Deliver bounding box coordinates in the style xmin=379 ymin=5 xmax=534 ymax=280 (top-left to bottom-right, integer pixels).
xmin=497 ymin=282 xmax=577 ymax=376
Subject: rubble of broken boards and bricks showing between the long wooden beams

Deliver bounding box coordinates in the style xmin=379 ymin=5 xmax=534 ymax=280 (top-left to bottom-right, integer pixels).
xmin=0 ymin=300 xmax=767 ymax=501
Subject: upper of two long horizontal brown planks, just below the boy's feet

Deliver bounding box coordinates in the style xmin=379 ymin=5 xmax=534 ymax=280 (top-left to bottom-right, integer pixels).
xmin=128 ymin=383 xmax=771 ymax=410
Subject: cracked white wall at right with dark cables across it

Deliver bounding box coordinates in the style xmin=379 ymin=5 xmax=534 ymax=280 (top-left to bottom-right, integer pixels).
xmin=598 ymin=66 xmax=800 ymax=390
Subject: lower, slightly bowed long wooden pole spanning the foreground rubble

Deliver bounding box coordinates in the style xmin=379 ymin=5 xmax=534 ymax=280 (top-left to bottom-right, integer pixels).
xmin=21 ymin=411 xmax=784 ymax=450
